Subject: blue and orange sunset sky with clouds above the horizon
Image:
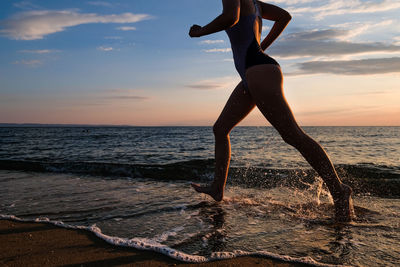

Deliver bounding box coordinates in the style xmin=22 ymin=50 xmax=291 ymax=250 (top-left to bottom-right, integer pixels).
xmin=0 ymin=0 xmax=400 ymax=126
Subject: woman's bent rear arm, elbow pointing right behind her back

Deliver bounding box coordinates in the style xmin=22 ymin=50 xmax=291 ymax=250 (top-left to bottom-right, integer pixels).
xmin=258 ymin=1 xmax=292 ymax=50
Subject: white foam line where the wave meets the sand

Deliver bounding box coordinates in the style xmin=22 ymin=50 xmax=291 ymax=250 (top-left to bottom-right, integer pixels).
xmin=0 ymin=214 xmax=350 ymax=267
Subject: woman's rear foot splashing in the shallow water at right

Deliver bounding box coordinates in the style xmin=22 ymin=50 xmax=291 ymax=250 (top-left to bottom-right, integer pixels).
xmin=334 ymin=184 xmax=354 ymax=222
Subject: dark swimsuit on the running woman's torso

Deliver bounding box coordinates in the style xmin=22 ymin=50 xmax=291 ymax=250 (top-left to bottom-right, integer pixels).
xmin=226 ymin=0 xmax=279 ymax=90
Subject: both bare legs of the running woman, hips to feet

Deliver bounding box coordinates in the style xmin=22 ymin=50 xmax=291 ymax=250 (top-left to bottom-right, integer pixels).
xmin=192 ymin=64 xmax=352 ymax=221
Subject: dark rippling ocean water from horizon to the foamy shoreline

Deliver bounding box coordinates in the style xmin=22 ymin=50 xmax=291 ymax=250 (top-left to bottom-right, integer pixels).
xmin=0 ymin=127 xmax=400 ymax=266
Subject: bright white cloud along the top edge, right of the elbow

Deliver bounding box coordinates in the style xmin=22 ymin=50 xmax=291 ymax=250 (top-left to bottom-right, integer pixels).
xmin=285 ymin=0 xmax=400 ymax=19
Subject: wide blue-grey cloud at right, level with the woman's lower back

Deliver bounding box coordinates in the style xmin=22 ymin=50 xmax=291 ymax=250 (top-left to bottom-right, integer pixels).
xmin=268 ymin=29 xmax=400 ymax=58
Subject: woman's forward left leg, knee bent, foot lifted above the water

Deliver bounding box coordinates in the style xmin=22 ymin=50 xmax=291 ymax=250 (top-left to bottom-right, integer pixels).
xmin=192 ymin=82 xmax=255 ymax=201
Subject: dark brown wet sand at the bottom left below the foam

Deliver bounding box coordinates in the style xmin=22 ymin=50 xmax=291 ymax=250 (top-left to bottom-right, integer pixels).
xmin=0 ymin=220 xmax=308 ymax=267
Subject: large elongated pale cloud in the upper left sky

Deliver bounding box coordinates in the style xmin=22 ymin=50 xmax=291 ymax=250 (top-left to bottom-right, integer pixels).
xmin=0 ymin=10 xmax=150 ymax=40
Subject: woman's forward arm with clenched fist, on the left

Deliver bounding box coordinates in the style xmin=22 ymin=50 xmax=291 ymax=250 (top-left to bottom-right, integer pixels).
xmin=189 ymin=0 xmax=240 ymax=37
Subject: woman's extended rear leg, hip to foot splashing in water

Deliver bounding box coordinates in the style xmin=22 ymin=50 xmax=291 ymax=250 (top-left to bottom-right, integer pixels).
xmin=246 ymin=65 xmax=352 ymax=221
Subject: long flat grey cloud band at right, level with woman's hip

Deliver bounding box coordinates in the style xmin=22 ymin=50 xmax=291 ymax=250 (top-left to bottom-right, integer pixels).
xmin=288 ymin=57 xmax=400 ymax=76
